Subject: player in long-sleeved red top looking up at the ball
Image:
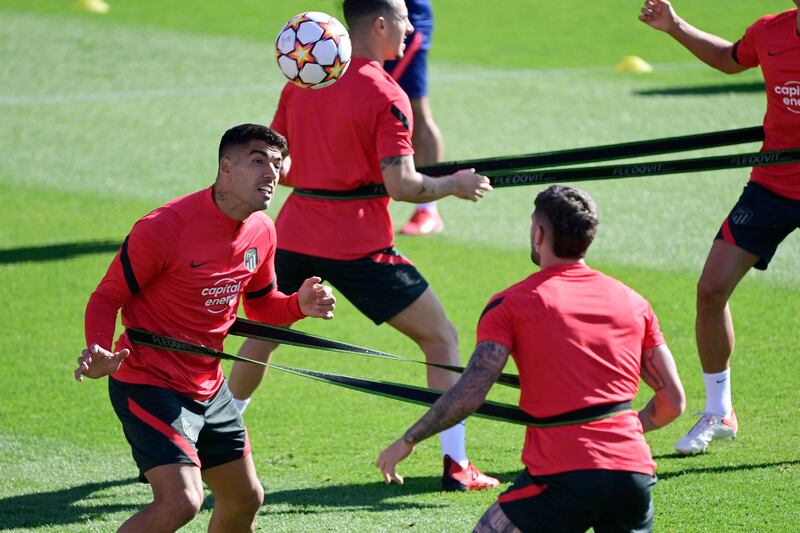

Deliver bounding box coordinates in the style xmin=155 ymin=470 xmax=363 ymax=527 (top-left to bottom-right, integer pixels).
xmin=75 ymin=124 xmax=335 ymax=532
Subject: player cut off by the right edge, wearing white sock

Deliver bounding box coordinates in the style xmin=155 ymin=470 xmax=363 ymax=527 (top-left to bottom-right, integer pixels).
xmin=639 ymin=0 xmax=800 ymax=454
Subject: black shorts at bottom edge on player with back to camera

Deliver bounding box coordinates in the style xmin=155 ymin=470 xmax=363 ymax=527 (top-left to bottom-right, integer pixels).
xmin=497 ymin=470 xmax=656 ymax=533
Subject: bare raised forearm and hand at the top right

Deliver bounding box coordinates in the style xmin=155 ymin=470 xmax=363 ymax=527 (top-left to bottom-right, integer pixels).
xmin=639 ymin=0 xmax=747 ymax=74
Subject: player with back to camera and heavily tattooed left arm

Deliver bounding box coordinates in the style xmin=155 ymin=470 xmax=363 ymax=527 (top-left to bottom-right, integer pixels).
xmin=376 ymin=185 xmax=685 ymax=532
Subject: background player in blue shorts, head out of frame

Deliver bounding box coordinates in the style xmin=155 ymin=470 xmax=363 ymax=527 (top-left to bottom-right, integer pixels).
xmin=383 ymin=0 xmax=444 ymax=235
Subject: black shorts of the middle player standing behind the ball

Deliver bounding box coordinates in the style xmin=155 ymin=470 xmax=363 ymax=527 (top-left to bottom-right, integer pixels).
xmin=275 ymin=248 xmax=428 ymax=324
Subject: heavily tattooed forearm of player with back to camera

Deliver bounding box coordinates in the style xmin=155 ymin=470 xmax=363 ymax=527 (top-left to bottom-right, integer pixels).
xmin=405 ymin=342 xmax=509 ymax=442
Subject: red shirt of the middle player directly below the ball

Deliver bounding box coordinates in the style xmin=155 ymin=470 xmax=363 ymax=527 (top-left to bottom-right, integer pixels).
xmin=271 ymin=57 xmax=414 ymax=259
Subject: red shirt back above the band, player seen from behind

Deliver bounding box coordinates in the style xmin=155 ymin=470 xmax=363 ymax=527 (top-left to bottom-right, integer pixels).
xmin=503 ymin=265 xmax=663 ymax=416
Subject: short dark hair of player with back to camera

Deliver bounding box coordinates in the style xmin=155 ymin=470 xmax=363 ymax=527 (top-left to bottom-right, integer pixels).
xmin=534 ymin=185 xmax=600 ymax=259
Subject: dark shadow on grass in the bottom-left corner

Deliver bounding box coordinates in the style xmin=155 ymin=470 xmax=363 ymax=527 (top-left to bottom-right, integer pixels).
xmin=0 ymin=478 xmax=141 ymax=531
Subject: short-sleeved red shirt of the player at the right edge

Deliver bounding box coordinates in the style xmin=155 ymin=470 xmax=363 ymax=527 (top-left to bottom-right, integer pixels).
xmin=734 ymin=9 xmax=800 ymax=200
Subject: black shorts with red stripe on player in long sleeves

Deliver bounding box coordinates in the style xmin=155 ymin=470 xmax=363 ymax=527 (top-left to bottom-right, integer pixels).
xmin=108 ymin=377 xmax=250 ymax=483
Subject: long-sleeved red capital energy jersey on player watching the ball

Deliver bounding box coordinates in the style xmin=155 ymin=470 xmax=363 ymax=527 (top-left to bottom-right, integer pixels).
xmin=85 ymin=188 xmax=303 ymax=400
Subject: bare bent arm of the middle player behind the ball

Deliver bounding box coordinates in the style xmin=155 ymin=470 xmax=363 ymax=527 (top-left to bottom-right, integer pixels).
xmin=381 ymin=155 xmax=492 ymax=203
